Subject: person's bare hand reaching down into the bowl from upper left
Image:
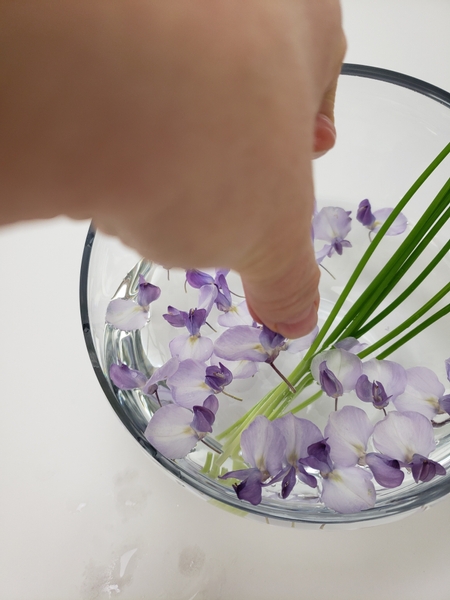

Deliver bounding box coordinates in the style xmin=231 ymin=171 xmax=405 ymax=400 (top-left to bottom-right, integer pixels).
xmin=0 ymin=0 xmax=345 ymax=337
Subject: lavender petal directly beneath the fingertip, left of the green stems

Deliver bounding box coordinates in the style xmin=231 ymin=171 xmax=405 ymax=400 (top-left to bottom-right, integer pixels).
xmin=214 ymin=325 xmax=268 ymax=362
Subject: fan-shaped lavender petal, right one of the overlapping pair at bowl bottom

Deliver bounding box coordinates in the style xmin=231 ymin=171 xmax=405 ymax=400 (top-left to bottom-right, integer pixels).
xmin=273 ymin=413 xmax=323 ymax=465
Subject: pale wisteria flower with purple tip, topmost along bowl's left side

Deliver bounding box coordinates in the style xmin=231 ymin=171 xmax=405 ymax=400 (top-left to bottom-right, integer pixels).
xmin=105 ymin=275 xmax=161 ymax=331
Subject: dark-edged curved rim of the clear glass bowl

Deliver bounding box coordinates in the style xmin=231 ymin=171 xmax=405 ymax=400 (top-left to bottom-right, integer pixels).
xmin=79 ymin=63 xmax=450 ymax=525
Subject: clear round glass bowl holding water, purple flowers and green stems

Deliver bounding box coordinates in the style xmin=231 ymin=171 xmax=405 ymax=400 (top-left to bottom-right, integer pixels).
xmin=80 ymin=64 xmax=450 ymax=529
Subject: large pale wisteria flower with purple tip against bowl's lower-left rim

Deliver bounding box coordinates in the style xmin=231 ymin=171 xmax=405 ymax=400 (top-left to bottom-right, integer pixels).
xmin=144 ymin=395 xmax=219 ymax=459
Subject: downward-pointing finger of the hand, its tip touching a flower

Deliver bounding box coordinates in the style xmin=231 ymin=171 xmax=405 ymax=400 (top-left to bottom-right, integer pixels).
xmin=241 ymin=214 xmax=320 ymax=338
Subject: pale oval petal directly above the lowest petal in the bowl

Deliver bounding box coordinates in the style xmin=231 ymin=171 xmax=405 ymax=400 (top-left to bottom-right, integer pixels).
xmin=324 ymin=406 xmax=373 ymax=467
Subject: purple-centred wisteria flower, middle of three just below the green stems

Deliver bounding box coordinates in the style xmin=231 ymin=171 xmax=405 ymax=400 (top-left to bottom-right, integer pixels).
xmin=355 ymin=358 xmax=408 ymax=410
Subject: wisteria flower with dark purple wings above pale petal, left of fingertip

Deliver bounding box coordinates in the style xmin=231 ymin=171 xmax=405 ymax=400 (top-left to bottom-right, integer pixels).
xmin=163 ymin=306 xmax=214 ymax=361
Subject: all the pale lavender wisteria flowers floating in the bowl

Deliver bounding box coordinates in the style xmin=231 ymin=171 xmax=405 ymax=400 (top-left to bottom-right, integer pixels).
xmin=106 ymin=200 xmax=450 ymax=513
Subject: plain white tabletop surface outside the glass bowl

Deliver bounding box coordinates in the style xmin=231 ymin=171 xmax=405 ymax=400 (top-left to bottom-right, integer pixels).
xmin=0 ymin=0 xmax=450 ymax=600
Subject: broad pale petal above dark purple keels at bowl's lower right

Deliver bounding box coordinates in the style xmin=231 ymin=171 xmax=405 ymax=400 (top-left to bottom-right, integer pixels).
xmin=373 ymin=412 xmax=436 ymax=463
